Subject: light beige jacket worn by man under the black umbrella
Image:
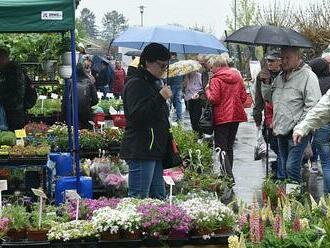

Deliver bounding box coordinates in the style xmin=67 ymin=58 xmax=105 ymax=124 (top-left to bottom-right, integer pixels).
xmin=262 ymin=65 xmax=321 ymax=135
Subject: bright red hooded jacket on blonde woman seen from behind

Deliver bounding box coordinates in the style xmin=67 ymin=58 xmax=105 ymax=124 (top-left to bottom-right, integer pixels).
xmin=206 ymin=67 xmax=247 ymax=125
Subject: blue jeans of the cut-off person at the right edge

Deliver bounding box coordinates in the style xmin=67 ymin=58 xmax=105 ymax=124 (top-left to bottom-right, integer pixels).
xmin=314 ymin=123 xmax=330 ymax=193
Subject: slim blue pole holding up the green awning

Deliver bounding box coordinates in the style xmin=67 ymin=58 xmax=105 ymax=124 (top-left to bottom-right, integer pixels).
xmin=70 ymin=30 xmax=80 ymax=193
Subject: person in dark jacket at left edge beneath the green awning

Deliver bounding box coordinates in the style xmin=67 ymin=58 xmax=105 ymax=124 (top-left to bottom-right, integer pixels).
xmin=0 ymin=48 xmax=35 ymax=131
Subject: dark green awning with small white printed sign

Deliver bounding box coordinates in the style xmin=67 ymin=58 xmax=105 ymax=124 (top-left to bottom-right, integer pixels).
xmin=0 ymin=0 xmax=75 ymax=33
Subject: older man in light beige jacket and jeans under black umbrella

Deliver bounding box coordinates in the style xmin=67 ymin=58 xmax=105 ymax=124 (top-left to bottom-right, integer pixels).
xmin=262 ymin=47 xmax=321 ymax=183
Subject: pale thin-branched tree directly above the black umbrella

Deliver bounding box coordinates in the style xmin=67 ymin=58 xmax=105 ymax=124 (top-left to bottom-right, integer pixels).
xmin=256 ymin=0 xmax=296 ymax=28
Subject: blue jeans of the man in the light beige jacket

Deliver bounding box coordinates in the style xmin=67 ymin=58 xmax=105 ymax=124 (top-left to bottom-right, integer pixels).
xmin=277 ymin=134 xmax=310 ymax=183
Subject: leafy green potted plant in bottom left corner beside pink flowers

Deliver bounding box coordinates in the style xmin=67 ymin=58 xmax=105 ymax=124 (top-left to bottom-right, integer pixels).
xmin=2 ymin=204 xmax=30 ymax=241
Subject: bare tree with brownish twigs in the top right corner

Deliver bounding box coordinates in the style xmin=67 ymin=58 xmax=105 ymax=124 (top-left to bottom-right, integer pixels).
xmin=296 ymin=0 xmax=330 ymax=56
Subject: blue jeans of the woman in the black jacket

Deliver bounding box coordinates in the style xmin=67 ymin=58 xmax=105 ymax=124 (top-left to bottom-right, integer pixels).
xmin=126 ymin=160 xmax=166 ymax=199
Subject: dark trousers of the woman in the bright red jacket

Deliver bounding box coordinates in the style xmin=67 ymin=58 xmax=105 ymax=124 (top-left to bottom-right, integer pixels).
xmin=214 ymin=122 xmax=239 ymax=178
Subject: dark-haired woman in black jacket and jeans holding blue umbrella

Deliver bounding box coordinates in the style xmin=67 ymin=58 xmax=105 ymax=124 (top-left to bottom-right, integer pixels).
xmin=120 ymin=43 xmax=172 ymax=199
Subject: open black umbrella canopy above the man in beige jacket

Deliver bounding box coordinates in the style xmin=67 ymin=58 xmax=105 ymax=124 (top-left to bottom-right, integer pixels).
xmin=225 ymin=26 xmax=312 ymax=48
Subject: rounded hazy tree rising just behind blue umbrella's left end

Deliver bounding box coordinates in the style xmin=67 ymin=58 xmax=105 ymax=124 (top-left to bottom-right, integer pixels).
xmin=102 ymin=10 xmax=128 ymax=40
